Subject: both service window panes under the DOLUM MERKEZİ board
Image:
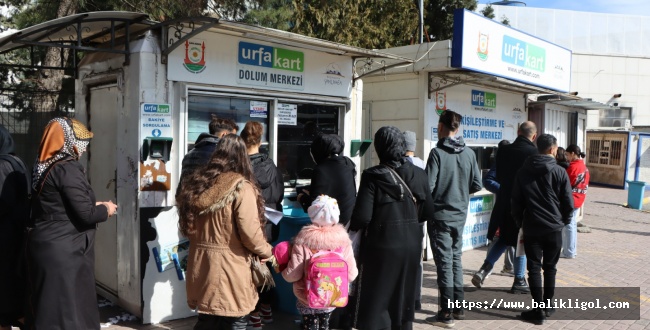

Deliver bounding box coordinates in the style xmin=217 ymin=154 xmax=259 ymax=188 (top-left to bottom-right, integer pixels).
xmin=187 ymin=94 xmax=344 ymax=187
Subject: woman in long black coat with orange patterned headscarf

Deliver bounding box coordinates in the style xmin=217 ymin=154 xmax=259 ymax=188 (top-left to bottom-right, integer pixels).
xmin=25 ymin=118 xmax=117 ymax=329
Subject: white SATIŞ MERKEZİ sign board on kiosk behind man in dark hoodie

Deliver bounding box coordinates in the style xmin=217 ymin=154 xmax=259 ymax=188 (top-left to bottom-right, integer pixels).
xmin=425 ymin=81 xmax=528 ymax=145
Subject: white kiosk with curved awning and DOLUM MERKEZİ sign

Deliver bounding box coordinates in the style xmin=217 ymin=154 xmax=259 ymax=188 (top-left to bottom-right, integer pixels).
xmin=0 ymin=12 xmax=412 ymax=323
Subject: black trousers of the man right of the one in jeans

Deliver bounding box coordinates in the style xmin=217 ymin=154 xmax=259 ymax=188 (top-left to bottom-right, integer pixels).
xmin=524 ymin=231 xmax=562 ymax=302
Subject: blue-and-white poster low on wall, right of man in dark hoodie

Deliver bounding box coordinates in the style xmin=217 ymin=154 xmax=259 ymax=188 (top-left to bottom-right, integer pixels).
xmin=463 ymin=195 xmax=494 ymax=251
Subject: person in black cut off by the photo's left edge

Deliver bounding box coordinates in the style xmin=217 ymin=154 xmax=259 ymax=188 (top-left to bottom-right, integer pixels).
xmin=0 ymin=125 xmax=30 ymax=330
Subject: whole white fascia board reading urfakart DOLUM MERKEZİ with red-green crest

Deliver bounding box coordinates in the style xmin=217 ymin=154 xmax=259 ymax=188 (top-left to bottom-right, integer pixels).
xmin=167 ymin=32 xmax=352 ymax=98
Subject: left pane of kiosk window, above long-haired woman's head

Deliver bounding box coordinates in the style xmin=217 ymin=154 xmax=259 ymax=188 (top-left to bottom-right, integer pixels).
xmin=187 ymin=95 xmax=271 ymax=152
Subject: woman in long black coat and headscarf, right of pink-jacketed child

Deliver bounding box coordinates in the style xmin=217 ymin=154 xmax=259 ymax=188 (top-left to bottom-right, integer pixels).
xmin=350 ymin=126 xmax=433 ymax=330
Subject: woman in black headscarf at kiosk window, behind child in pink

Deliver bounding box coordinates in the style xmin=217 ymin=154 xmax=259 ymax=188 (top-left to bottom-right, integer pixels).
xmin=298 ymin=134 xmax=357 ymax=226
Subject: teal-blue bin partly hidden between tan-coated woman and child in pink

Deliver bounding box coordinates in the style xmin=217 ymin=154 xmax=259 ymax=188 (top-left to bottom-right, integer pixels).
xmin=272 ymin=208 xmax=311 ymax=315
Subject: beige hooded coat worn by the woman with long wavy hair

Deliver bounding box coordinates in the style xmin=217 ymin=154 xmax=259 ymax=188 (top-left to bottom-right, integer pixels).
xmin=186 ymin=173 xmax=271 ymax=317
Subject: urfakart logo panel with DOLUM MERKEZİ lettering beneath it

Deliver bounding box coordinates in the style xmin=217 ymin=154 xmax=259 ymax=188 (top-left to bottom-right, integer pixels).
xmin=237 ymin=41 xmax=305 ymax=90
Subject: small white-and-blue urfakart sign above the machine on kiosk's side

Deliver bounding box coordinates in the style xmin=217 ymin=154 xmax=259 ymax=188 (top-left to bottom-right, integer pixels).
xmin=140 ymin=103 xmax=173 ymax=141
